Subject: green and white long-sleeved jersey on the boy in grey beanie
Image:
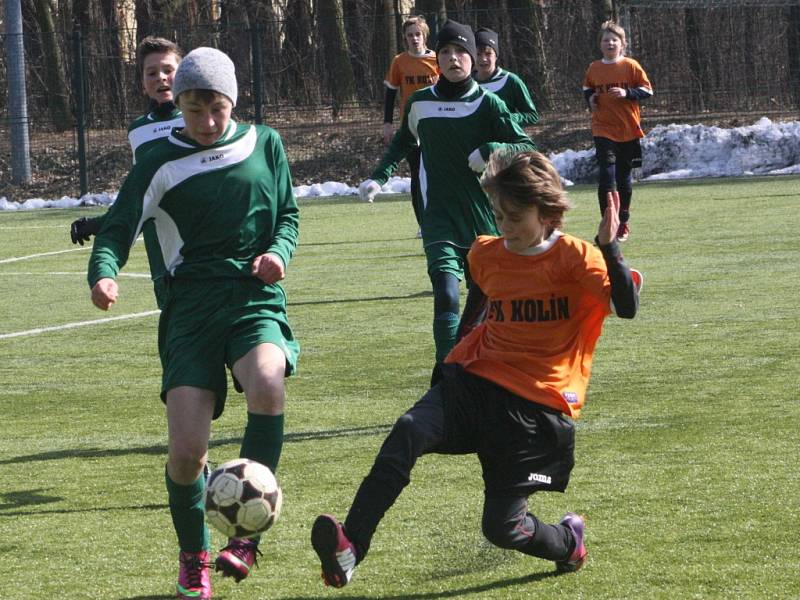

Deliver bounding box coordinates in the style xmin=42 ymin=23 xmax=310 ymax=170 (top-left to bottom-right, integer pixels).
xmin=88 ymin=121 xmax=299 ymax=287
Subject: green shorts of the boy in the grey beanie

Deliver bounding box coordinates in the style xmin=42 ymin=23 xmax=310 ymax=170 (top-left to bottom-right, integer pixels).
xmin=158 ymin=278 xmax=300 ymax=419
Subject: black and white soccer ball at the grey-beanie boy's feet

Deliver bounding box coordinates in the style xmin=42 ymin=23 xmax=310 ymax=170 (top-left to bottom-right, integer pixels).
xmin=206 ymin=458 xmax=283 ymax=538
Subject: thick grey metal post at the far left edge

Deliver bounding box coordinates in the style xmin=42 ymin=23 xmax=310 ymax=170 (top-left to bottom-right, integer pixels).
xmin=5 ymin=0 xmax=31 ymax=184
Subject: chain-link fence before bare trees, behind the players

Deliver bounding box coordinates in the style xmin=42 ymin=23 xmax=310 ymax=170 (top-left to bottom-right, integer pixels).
xmin=0 ymin=0 xmax=800 ymax=195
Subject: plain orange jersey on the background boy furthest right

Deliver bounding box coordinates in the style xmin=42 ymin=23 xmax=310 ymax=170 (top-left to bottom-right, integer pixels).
xmin=583 ymin=57 xmax=653 ymax=142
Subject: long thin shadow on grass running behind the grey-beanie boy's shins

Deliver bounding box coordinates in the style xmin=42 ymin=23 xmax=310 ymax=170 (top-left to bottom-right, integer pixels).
xmin=0 ymin=425 xmax=391 ymax=466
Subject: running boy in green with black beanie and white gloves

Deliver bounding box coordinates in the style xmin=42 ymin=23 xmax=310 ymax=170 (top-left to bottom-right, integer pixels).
xmin=359 ymin=21 xmax=536 ymax=363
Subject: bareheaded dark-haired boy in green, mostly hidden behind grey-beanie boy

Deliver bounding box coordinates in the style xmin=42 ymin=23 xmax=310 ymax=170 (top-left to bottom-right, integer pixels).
xmin=70 ymin=36 xmax=184 ymax=308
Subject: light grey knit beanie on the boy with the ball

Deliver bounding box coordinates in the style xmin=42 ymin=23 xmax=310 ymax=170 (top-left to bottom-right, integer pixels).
xmin=172 ymin=47 xmax=238 ymax=106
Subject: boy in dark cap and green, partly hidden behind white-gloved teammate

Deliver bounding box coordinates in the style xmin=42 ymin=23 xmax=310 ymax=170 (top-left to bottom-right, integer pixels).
xmin=474 ymin=27 xmax=539 ymax=127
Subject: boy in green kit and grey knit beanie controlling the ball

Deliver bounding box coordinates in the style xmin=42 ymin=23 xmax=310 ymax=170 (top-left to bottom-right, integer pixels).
xmin=88 ymin=48 xmax=299 ymax=599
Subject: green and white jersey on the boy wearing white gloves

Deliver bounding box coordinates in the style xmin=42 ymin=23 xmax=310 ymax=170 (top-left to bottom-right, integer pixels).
xmin=371 ymin=82 xmax=536 ymax=248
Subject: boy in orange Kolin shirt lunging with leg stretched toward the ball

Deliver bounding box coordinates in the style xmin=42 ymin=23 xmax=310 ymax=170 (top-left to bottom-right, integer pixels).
xmin=311 ymin=152 xmax=641 ymax=587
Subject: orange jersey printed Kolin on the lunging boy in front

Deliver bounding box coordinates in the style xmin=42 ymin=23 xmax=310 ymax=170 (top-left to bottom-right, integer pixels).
xmin=445 ymin=232 xmax=611 ymax=418
